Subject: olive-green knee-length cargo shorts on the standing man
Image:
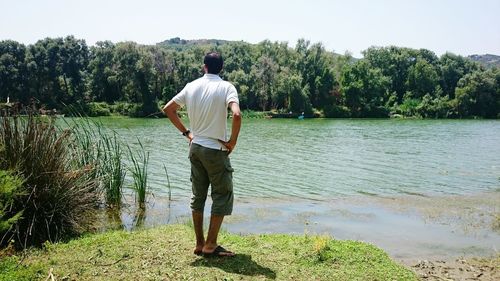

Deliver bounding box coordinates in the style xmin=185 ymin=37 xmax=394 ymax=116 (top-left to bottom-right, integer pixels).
xmin=189 ymin=143 xmax=234 ymax=216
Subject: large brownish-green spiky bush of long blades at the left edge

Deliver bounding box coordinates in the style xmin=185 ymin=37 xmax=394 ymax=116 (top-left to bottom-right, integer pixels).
xmin=0 ymin=116 xmax=99 ymax=248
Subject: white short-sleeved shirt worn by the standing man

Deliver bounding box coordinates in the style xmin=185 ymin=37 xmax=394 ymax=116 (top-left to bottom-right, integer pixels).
xmin=172 ymin=74 xmax=239 ymax=150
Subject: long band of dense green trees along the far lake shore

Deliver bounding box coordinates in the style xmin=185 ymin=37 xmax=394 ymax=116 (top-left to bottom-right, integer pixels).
xmin=0 ymin=36 xmax=500 ymax=118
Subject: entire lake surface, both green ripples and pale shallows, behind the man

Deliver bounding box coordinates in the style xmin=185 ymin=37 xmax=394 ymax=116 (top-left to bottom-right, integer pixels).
xmin=92 ymin=117 xmax=500 ymax=257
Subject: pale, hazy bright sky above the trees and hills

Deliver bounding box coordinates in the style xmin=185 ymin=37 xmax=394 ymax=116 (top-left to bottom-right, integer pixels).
xmin=0 ymin=0 xmax=500 ymax=57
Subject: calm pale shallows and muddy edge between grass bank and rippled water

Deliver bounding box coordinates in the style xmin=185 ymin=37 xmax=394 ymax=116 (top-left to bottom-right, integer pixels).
xmin=98 ymin=191 xmax=500 ymax=280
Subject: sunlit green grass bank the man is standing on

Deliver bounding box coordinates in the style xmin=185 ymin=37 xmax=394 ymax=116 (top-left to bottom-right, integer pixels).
xmin=0 ymin=225 xmax=417 ymax=280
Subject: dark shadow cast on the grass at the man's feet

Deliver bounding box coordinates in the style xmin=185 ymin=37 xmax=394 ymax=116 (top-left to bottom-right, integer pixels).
xmin=191 ymin=254 xmax=276 ymax=279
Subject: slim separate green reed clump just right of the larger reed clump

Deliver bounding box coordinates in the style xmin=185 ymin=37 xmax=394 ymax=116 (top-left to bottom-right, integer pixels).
xmin=127 ymin=139 xmax=149 ymax=207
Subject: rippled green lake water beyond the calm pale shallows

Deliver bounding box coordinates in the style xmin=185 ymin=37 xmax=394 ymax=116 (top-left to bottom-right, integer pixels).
xmin=94 ymin=117 xmax=500 ymax=200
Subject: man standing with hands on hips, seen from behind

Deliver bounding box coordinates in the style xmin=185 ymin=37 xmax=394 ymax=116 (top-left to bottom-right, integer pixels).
xmin=163 ymin=52 xmax=241 ymax=257
